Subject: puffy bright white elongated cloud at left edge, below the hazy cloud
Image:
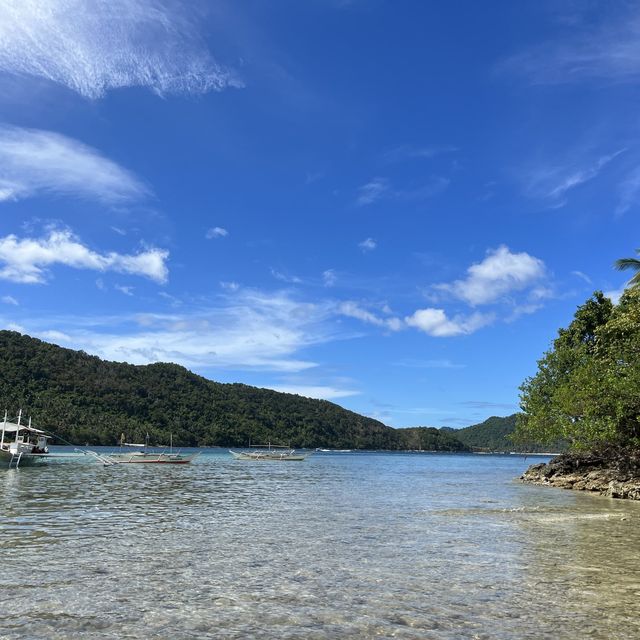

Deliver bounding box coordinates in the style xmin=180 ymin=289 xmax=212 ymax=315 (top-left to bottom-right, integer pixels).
xmin=0 ymin=230 xmax=169 ymax=284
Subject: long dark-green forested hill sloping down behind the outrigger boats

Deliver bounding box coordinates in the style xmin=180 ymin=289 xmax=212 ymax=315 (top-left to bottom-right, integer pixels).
xmin=0 ymin=331 xmax=466 ymax=450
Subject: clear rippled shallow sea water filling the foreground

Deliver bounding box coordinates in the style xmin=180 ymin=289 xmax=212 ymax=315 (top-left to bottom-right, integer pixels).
xmin=0 ymin=452 xmax=640 ymax=640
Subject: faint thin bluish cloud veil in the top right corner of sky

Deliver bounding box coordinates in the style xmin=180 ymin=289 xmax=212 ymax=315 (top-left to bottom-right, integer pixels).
xmin=499 ymin=11 xmax=640 ymax=84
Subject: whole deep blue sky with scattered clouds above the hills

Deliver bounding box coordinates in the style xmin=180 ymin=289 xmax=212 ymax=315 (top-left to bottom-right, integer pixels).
xmin=0 ymin=0 xmax=640 ymax=427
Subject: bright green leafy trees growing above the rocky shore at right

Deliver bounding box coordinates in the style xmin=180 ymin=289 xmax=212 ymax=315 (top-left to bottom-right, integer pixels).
xmin=516 ymin=288 xmax=640 ymax=449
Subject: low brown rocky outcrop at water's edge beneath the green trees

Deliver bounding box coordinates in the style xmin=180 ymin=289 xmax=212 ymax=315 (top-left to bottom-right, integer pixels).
xmin=520 ymin=450 xmax=640 ymax=500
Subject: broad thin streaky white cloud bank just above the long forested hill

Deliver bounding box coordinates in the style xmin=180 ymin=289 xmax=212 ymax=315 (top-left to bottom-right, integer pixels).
xmin=22 ymin=290 xmax=340 ymax=373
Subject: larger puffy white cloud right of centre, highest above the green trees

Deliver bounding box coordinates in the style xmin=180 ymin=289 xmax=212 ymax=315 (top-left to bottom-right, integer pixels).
xmin=435 ymin=245 xmax=546 ymax=306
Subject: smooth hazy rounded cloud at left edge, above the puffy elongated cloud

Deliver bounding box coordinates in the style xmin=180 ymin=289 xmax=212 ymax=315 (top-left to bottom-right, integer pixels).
xmin=0 ymin=126 xmax=148 ymax=204
